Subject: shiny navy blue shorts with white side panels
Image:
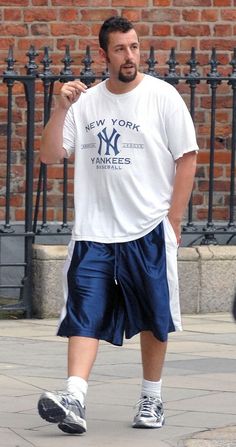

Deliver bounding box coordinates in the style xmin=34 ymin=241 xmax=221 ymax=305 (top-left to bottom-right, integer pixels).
xmin=58 ymin=217 xmax=181 ymax=345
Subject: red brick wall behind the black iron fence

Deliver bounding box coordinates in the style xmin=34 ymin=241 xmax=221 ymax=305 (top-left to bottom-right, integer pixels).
xmin=0 ymin=0 xmax=236 ymax=224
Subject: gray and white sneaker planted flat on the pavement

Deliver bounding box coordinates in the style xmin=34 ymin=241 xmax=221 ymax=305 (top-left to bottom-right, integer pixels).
xmin=132 ymin=396 xmax=165 ymax=428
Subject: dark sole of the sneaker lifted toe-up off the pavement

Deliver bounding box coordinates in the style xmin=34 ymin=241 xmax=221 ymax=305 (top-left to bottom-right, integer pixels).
xmin=38 ymin=396 xmax=67 ymax=424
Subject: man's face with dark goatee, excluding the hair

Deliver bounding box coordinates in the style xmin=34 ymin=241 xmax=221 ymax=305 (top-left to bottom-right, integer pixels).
xmin=103 ymin=29 xmax=140 ymax=83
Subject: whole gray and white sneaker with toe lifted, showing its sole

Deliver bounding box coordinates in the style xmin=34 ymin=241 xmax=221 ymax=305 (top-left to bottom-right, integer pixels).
xmin=38 ymin=391 xmax=87 ymax=434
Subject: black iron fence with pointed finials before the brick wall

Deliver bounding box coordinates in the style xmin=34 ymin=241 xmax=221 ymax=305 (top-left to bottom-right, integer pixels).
xmin=0 ymin=46 xmax=236 ymax=316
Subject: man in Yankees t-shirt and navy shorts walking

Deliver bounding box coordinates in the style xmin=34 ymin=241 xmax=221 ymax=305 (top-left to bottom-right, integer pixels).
xmin=38 ymin=17 xmax=198 ymax=433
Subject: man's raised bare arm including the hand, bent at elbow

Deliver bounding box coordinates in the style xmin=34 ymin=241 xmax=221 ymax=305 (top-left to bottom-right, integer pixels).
xmin=40 ymin=81 xmax=87 ymax=164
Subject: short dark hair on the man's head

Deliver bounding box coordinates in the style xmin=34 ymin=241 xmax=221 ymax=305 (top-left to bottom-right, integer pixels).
xmin=98 ymin=16 xmax=134 ymax=52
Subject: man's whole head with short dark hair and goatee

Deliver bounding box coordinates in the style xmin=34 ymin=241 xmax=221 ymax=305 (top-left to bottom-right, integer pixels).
xmin=99 ymin=16 xmax=140 ymax=83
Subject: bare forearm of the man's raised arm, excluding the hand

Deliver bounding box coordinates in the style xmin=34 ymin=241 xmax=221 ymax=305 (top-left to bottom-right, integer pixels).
xmin=40 ymin=107 xmax=67 ymax=163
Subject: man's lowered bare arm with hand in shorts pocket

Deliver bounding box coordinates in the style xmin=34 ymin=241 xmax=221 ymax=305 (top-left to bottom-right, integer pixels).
xmin=168 ymin=151 xmax=197 ymax=243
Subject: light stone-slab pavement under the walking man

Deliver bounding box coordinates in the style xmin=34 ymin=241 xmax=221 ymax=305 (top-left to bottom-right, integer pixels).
xmin=0 ymin=313 xmax=236 ymax=447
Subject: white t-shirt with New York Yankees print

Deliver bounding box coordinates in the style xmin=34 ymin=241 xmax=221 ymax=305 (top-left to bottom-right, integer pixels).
xmin=63 ymin=75 xmax=198 ymax=243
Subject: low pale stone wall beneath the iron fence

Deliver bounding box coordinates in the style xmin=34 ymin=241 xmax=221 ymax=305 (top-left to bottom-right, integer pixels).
xmin=32 ymin=245 xmax=236 ymax=318
